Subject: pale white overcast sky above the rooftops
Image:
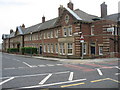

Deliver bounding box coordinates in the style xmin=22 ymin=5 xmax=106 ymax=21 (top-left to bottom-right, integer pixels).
xmin=0 ymin=0 xmax=120 ymax=43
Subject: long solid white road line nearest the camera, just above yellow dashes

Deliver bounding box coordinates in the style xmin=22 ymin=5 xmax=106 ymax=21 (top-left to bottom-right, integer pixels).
xmin=18 ymin=78 xmax=87 ymax=89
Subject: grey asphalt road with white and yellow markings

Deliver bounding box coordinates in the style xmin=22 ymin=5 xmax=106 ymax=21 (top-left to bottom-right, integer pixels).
xmin=0 ymin=53 xmax=120 ymax=90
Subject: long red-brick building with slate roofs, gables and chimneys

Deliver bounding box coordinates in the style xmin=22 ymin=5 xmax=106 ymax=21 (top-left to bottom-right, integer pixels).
xmin=2 ymin=1 xmax=120 ymax=58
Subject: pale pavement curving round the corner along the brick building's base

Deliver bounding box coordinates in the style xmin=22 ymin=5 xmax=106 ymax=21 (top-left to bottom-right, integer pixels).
xmin=7 ymin=52 xmax=120 ymax=64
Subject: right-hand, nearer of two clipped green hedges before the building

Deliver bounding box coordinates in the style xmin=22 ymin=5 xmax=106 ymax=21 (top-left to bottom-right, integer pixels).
xmin=21 ymin=47 xmax=37 ymax=54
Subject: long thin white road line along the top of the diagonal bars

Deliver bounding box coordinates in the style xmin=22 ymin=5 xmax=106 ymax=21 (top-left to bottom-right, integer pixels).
xmin=2 ymin=71 xmax=70 ymax=79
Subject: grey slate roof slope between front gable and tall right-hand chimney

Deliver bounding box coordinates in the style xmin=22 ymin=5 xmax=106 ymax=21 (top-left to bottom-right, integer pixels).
xmin=74 ymin=9 xmax=100 ymax=22
